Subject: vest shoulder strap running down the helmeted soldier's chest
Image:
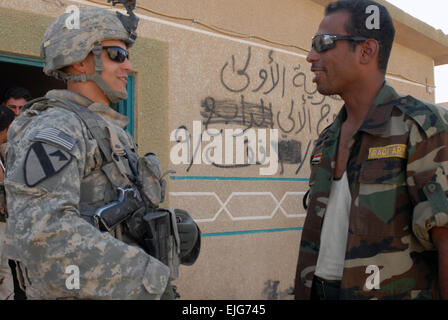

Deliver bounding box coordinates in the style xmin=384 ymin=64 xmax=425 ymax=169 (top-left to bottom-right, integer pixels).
xmin=51 ymin=98 xmax=134 ymax=188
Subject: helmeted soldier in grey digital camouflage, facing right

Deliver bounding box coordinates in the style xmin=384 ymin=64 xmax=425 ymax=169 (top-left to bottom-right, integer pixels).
xmin=0 ymin=1 xmax=199 ymax=299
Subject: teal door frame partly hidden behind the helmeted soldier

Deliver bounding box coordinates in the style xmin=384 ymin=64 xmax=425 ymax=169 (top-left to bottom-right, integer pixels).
xmin=0 ymin=52 xmax=135 ymax=136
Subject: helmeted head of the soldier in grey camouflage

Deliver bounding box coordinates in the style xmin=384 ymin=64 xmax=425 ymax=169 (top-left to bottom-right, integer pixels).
xmin=41 ymin=1 xmax=138 ymax=104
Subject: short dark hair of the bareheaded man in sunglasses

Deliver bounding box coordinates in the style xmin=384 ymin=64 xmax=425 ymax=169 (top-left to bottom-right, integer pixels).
xmin=325 ymin=0 xmax=395 ymax=72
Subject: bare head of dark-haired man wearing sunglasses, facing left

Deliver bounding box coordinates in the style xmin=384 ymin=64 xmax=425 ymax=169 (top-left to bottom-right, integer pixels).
xmin=307 ymin=0 xmax=395 ymax=97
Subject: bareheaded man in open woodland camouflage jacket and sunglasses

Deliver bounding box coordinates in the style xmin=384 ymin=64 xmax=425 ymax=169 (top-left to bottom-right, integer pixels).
xmin=295 ymin=0 xmax=448 ymax=300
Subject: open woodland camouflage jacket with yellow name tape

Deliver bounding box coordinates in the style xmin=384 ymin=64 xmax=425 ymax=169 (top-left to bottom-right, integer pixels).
xmin=295 ymin=83 xmax=448 ymax=299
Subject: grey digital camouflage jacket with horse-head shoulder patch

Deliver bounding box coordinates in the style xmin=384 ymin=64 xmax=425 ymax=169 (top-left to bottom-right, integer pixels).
xmin=4 ymin=90 xmax=170 ymax=299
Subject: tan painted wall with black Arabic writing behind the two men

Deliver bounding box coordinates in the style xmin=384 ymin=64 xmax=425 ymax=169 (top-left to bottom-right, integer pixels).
xmin=0 ymin=0 xmax=446 ymax=299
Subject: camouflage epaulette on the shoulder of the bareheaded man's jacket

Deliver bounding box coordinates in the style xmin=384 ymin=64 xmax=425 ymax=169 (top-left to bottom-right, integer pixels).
xmin=396 ymin=95 xmax=448 ymax=137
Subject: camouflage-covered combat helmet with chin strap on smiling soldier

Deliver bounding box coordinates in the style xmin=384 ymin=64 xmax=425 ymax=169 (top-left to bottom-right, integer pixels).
xmin=40 ymin=0 xmax=138 ymax=102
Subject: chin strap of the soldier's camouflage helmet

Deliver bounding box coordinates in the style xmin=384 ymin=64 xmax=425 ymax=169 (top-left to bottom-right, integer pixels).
xmin=54 ymin=43 xmax=128 ymax=103
